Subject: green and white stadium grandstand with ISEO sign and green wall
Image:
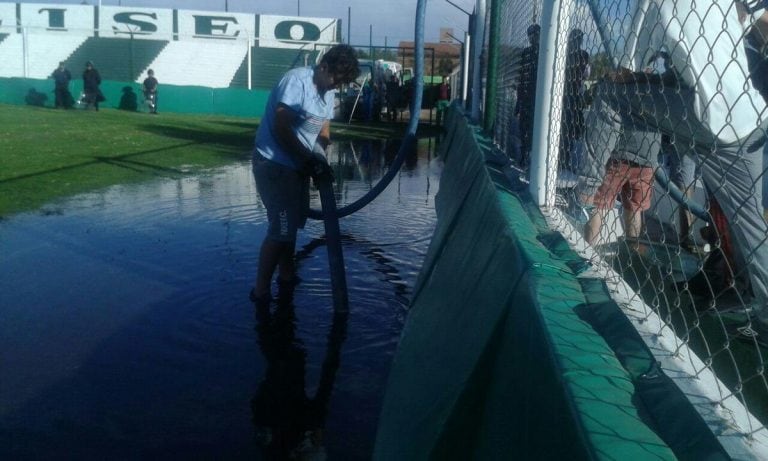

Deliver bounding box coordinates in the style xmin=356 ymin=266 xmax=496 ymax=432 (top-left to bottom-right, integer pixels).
xmin=0 ymin=3 xmax=341 ymax=115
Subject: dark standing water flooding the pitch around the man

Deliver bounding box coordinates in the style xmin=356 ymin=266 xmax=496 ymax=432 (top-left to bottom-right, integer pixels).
xmin=0 ymin=137 xmax=440 ymax=459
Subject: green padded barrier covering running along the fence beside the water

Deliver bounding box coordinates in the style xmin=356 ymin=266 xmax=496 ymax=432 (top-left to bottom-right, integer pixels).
xmin=374 ymin=108 xmax=675 ymax=460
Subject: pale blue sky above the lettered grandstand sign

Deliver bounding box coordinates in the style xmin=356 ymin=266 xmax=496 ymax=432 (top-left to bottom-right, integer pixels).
xmin=0 ymin=0 xmax=475 ymax=46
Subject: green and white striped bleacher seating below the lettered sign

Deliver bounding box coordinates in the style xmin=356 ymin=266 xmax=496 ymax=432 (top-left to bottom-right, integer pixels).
xmin=0 ymin=33 xmax=318 ymax=90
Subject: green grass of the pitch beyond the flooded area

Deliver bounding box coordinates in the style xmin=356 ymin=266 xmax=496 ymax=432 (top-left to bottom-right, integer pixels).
xmin=0 ymin=105 xmax=432 ymax=218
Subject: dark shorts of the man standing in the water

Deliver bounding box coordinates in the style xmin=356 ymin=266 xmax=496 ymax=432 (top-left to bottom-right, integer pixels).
xmin=253 ymin=156 xmax=309 ymax=242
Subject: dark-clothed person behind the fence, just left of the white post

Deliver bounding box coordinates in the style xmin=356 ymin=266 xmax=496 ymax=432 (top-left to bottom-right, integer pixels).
xmin=515 ymin=24 xmax=541 ymax=168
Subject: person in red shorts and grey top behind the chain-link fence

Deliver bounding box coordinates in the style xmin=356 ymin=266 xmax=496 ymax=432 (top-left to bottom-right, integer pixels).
xmin=584 ymin=122 xmax=661 ymax=245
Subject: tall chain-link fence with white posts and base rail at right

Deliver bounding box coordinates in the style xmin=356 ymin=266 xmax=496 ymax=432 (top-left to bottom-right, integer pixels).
xmin=487 ymin=0 xmax=768 ymax=450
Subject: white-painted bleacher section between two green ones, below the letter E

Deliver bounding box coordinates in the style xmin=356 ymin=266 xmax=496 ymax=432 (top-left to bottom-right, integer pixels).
xmin=149 ymin=40 xmax=248 ymax=88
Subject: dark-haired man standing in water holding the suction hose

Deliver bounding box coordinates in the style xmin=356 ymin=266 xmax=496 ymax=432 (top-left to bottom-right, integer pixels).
xmin=250 ymin=45 xmax=359 ymax=305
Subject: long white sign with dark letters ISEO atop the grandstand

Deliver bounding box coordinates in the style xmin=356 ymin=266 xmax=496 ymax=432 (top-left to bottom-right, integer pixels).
xmin=0 ymin=3 xmax=339 ymax=48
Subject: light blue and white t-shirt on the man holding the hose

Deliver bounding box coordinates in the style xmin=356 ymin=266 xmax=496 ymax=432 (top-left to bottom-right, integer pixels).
xmin=254 ymin=67 xmax=335 ymax=169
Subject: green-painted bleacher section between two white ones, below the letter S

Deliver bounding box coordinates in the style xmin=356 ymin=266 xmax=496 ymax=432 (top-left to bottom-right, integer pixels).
xmin=66 ymin=37 xmax=168 ymax=81
